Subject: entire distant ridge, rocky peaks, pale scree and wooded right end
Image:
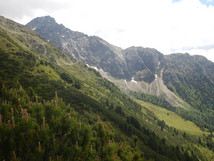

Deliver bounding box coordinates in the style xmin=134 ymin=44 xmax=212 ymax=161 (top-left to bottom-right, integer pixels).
xmin=27 ymin=16 xmax=214 ymax=109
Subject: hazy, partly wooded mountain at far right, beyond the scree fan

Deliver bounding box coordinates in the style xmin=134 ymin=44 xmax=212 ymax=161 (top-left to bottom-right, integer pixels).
xmin=163 ymin=54 xmax=214 ymax=110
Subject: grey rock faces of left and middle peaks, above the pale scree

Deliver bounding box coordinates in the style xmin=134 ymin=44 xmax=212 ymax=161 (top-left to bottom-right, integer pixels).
xmin=27 ymin=16 xmax=167 ymax=82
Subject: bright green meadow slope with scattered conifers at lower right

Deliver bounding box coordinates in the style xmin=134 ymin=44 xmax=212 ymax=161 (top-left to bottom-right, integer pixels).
xmin=136 ymin=100 xmax=214 ymax=160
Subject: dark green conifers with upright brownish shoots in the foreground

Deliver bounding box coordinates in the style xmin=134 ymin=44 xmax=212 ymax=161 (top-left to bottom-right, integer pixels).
xmin=0 ymin=81 xmax=197 ymax=161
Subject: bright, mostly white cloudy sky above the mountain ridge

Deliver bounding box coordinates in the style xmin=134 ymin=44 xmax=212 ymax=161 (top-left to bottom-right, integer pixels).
xmin=0 ymin=0 xmax=214 ymax=62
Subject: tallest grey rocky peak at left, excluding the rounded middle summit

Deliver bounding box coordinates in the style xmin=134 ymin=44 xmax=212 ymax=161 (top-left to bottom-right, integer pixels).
xmin=27 ymin=16 xmax=129 ymax=78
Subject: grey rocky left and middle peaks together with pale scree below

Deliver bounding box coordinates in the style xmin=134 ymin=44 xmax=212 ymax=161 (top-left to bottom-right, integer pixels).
xmin=27 ymin=16 xmax=184 ymax=107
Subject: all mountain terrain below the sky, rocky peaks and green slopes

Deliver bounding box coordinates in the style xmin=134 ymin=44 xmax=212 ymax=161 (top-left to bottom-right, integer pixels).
xmin=0 ymin=16 xmax=214 ymax=161
